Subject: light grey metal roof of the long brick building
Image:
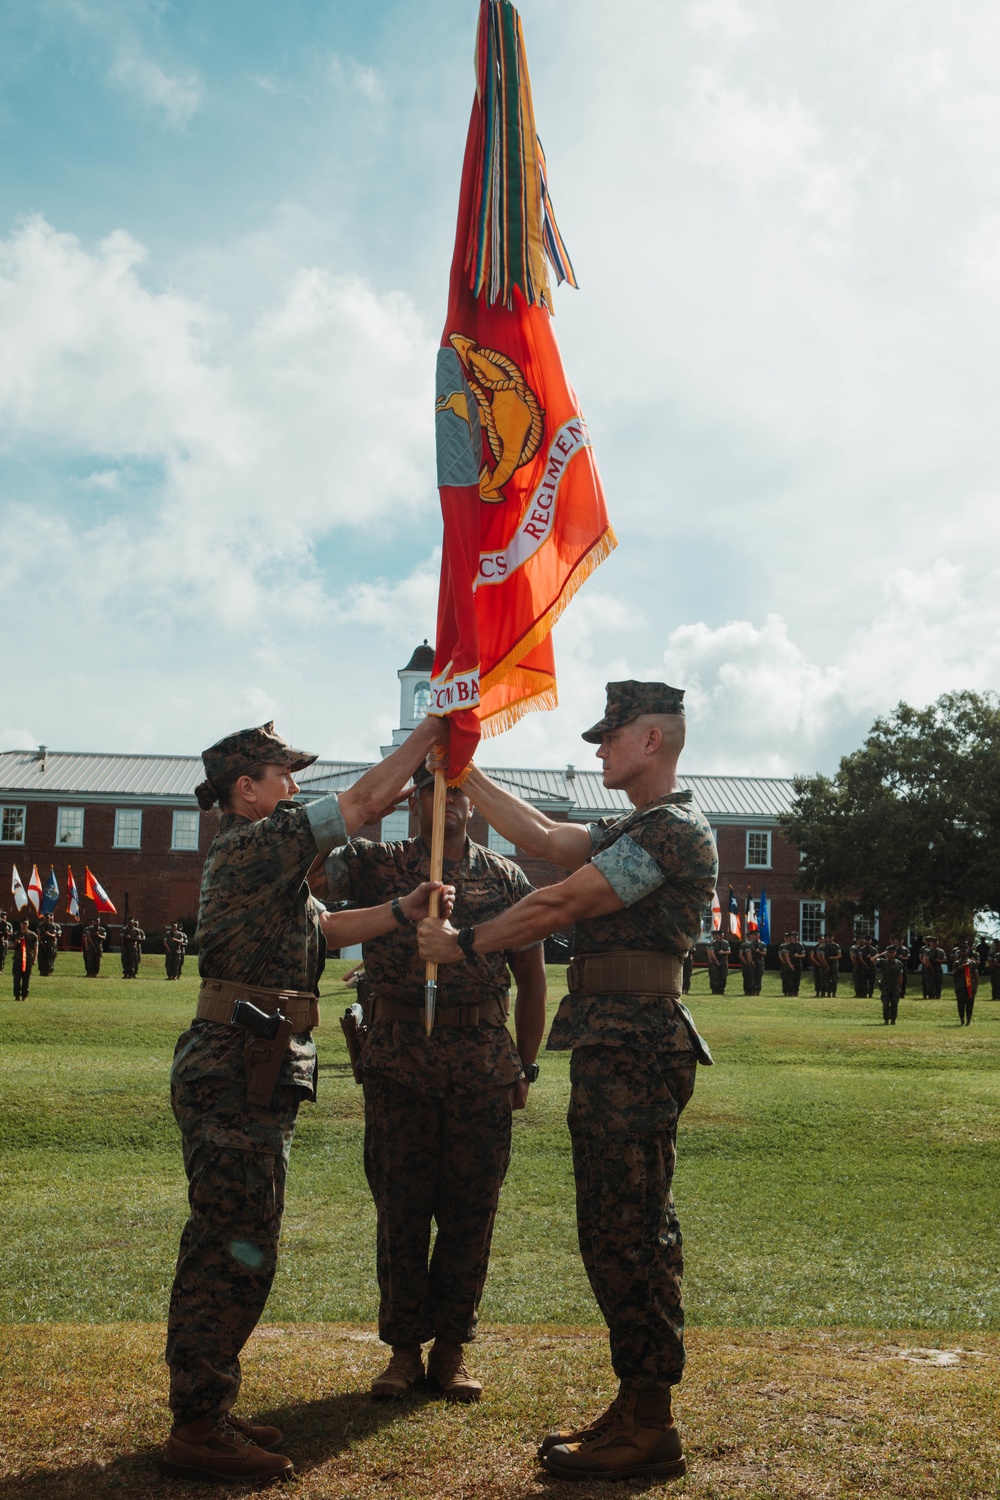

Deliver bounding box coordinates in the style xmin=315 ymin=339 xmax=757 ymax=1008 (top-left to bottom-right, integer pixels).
xmin=0 ymin=750 xmax=793 ymax=821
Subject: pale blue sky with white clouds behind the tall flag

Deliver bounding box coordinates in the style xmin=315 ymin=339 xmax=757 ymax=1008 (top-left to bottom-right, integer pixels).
xmin=0 ymin=0 xmax=1000 ymax=774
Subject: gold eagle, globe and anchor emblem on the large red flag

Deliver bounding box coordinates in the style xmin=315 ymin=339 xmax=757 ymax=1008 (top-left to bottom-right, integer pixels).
xmin=435 ymin=333 xmax=546 ymax=506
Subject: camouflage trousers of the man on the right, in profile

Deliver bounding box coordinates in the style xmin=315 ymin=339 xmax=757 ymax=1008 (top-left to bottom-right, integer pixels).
xmin=568 ymin=1046 xmax=696 ymax=1391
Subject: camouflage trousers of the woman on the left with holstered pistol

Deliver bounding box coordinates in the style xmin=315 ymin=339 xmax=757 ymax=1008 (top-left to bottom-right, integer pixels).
xmin=166 ymin=1079 xmax=300 ymax=1424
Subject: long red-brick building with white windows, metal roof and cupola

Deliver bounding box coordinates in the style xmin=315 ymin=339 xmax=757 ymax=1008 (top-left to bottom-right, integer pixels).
xmin=0 ymin=642 xmax=843 ymax=945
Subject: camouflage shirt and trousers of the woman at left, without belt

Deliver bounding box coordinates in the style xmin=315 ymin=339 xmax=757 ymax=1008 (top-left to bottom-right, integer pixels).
xmin=166 ymin=797 xmax=346 ymax=1425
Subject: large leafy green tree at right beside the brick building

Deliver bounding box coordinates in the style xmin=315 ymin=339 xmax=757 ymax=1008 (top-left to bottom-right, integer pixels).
xmin=781 ymin=692 xmax=1000 ymax=933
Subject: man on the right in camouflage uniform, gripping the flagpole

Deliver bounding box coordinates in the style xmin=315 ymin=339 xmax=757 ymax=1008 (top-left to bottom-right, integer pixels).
xmin=420 ymin=683 xmax=718 ymax=1479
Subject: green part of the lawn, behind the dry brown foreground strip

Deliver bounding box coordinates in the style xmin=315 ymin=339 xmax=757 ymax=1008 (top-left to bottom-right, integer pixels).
xmin=0 ymin=956 xmax=1000 ymax=1331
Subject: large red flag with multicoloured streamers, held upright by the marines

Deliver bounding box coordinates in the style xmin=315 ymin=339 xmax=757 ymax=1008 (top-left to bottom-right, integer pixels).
xmin=432 ymin=0 xmax=616 ymax=782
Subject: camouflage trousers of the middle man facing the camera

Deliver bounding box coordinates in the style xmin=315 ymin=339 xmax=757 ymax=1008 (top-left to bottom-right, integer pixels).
xmin=364 ymin=1073 xmax=511 ymax=1346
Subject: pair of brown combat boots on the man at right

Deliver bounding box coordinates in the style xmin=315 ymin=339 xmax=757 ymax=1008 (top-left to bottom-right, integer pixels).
xmin=541 ymin=1386 xmax=687 ymax=1479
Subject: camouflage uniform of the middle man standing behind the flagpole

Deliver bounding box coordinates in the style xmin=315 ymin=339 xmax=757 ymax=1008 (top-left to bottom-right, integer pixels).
xmin=325 ymin=839 xmax=532 ymax=1347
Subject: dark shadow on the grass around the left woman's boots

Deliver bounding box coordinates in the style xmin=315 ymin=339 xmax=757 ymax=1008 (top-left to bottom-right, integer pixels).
xmin=0 ymin=1392 xmax=419 ymax=1500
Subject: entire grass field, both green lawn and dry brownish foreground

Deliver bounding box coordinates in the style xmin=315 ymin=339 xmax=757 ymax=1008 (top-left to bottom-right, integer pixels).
xmin=0 ymin=956 xmax=1000 ymax=1500
